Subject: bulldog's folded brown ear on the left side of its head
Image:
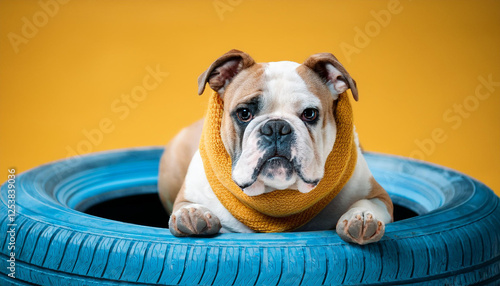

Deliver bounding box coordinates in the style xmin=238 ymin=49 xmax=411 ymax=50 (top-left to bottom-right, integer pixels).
xmin=198 ymin=50 xmax=255 ymax=95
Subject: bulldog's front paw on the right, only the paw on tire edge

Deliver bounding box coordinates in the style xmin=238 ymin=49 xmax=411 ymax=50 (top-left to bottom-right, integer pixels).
xmin=337 ymin=208 xmax=385 ymax=245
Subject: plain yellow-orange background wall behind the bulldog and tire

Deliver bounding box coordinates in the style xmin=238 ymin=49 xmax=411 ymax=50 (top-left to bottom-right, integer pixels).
xmin=0 ymin=0 xmax=500 ymax=194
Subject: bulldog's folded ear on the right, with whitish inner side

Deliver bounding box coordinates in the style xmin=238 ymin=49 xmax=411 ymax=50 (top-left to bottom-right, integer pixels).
xmin=304 ymin=53 xmax=359 ymax=101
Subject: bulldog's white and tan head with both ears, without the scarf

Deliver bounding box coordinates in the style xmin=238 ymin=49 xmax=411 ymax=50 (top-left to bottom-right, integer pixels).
xmin=199 ymin=50 xmax=357 ymax=196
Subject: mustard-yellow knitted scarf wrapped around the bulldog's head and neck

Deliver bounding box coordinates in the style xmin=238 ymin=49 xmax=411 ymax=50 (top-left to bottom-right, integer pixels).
xmin=200 ymin=92 xmax=357 ymax=232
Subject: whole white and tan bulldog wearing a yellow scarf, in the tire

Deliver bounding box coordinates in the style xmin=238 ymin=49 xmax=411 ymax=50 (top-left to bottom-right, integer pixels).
xmin=158 ymin=50 xmax=393 ymax=245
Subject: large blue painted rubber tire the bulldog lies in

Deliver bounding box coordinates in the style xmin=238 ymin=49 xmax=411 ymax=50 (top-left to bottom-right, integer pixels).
xmin=0 ymin=148 xmax=500 ymax=285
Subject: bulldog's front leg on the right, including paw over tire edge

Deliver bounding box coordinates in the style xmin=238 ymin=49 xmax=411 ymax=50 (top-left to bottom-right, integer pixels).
xmin=337 ymin=178 xmax=393 ymax=245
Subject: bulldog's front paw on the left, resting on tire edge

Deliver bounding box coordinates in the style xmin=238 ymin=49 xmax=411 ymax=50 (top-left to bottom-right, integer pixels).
xmin=168 ymin=204 xmax=222 ymax=236
